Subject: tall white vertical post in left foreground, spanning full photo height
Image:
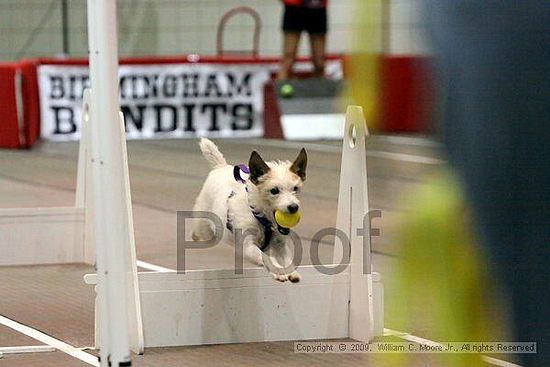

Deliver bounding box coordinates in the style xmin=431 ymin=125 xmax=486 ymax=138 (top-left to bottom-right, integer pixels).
xmin=84 ymin=0 xmax=137 ymax=366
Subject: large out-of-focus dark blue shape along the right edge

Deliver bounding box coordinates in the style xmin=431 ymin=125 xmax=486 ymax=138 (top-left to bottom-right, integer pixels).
xmin=425 ymin=0 xmax=550 ymax=366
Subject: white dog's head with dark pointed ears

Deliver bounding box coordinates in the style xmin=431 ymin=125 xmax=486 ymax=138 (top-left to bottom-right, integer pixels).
xmin=248 ymin=148 xmax=307 ymax=215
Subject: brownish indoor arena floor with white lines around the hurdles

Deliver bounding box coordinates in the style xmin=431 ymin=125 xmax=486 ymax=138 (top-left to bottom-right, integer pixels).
xmin=0 ymin=136 xmax=516 ymax=367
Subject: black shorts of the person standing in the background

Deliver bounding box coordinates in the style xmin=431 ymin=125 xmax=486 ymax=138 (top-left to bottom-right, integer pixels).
xmin=283 ymin=5 xmax=327 ymax=34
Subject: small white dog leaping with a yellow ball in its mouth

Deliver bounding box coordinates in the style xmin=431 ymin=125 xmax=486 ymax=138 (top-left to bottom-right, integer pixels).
xmin=193 ymin=139 xmax=307 ymax=283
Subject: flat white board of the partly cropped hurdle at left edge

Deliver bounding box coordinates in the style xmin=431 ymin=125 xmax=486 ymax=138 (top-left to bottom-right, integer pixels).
xmin=0 ymin=207 xmax=84 ymax=266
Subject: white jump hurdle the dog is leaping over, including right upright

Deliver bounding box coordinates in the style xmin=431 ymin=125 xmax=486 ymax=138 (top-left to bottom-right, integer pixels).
xmin=85 ymin=106 xmax=384 ymax=351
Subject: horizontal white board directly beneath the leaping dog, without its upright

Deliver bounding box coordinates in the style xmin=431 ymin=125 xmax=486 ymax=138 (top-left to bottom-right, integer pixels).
xmin=85 ymin=266 xmax=383 ymax=347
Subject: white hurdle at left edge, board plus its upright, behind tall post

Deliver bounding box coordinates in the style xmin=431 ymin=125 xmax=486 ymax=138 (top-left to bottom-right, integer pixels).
xmin=0 ymin=88 xmax=95 ymax=266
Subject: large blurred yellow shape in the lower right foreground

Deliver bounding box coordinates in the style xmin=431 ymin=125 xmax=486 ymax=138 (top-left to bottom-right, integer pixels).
xmin=388 ymin=171 xmax=505 ymax=367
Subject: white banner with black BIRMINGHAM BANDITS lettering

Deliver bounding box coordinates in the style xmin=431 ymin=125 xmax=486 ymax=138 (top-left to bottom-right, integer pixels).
xmin=38 ymin=63 xmax=270 ymax=141
